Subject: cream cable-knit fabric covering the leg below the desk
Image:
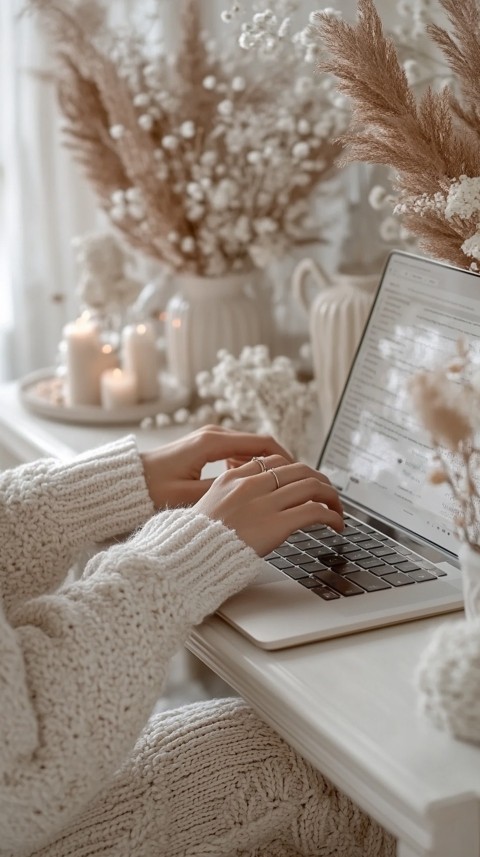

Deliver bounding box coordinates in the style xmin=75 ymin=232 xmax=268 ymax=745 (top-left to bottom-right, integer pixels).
xmin=24 ymin=699 xmax=395 ymax=857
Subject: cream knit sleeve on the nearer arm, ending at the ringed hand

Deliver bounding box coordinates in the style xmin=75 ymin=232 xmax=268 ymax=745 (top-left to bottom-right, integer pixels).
xmin=0 ymin=502 xmax=262 ymax=853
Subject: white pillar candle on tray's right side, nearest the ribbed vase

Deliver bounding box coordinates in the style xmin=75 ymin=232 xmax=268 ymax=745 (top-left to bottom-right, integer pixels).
xmin=122 ymin=324 xmax=160 ymax=402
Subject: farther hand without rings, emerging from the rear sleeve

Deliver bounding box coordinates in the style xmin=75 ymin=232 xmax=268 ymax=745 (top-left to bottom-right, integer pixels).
xmin=140 ymin=426 xmax=291 ymax=509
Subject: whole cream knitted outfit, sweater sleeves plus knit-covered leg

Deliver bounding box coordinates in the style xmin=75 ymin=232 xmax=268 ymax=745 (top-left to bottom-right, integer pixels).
xmin=0 ymin=438 xmax=394 ymax=857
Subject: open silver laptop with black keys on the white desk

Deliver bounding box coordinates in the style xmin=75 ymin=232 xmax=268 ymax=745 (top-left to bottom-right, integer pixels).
xmin=219 ymin=251 xmax=480 ymax=649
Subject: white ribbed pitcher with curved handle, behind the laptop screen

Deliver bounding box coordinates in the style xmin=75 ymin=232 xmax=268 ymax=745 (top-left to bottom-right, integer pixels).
xmin=292 ymin=258 xmax=380 ymax=436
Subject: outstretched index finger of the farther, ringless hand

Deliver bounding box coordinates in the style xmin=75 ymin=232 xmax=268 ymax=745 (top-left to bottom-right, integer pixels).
xmin=197 ymin=427 xmax=293 ymax=462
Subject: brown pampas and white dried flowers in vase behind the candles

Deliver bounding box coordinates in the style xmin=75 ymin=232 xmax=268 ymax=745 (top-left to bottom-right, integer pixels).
xmin=28 ymin=0 xmax=347 ymax=276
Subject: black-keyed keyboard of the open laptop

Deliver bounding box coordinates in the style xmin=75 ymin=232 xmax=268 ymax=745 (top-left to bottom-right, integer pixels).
xmin=265 ymin=516 xmax=446 ymax=601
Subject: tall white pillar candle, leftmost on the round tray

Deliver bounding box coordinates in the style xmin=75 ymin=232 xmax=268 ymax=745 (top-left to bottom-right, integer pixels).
xmin=63 ymin=313 xmax=101 ymax=405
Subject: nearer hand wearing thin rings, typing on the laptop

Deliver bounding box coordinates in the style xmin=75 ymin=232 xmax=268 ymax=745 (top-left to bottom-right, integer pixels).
xmin=195 ymin=455 xmax=344 ymax=556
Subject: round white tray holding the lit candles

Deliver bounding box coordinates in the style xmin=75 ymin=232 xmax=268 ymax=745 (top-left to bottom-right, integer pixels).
xmin=19 ymin=369 xmax=190 ymax=426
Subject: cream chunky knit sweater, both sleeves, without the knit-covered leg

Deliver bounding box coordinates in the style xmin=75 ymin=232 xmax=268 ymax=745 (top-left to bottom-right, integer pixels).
xmin=0 ymin=438 xmax=260 ymax=853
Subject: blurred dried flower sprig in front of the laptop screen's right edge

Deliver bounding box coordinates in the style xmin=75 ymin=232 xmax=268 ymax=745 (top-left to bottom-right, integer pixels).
xmin=410 ymin=341 xmax=480 ymax=551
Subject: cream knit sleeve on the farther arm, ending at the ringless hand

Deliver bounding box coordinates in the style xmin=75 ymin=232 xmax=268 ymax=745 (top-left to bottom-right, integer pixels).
xmin=0 ymin=436 xmax=154 ymax=611
